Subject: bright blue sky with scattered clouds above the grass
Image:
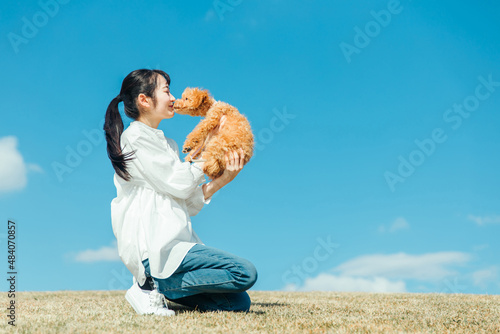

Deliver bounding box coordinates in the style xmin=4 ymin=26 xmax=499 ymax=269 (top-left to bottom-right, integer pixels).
xmin=0 ymin=0 xmax=500 ymax=294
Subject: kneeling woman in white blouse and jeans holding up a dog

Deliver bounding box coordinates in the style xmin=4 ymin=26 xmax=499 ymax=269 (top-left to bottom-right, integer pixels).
xmin=104 ymin=69 xmax=257 ymax=316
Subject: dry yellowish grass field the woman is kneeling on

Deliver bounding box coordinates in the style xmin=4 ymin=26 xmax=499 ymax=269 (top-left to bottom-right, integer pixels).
xmin=0 ymin=291 xmax=500 ymax=333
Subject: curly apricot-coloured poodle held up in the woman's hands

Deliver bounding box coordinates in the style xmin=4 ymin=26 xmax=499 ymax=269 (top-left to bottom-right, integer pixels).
xmin=174 ymin=87 xmax=254 ymax=180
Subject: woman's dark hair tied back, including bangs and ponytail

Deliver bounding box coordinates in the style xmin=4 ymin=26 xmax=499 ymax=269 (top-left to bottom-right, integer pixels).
xmin=104 ymin=69 xmax=170 ymax=181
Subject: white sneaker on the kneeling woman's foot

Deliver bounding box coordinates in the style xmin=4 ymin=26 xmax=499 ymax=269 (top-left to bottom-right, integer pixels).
xmin=125 ymin=283 xmax=175 ymax=316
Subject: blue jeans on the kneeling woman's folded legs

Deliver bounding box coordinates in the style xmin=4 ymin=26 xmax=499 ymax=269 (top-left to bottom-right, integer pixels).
xmin=142 ymin=244 xmax=257 ymax=312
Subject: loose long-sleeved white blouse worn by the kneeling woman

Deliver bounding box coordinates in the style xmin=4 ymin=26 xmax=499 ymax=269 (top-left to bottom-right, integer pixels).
xmin=111 ymin=121 xmax=211 ymax=285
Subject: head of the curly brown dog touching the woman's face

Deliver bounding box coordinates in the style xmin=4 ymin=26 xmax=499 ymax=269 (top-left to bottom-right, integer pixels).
xmin=174 ymin=87 xmax=213 ymax=116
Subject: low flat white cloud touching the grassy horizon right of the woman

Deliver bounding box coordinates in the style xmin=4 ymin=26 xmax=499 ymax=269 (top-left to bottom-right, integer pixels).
xmin=284 ymin=273 xmax=406 ymax=292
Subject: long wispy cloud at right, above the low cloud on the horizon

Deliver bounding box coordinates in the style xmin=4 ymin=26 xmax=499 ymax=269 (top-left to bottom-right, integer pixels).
xmin=333 ymin=252 xmax=471 ymax=281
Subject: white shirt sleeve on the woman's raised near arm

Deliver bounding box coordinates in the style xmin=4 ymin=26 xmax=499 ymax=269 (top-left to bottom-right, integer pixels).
xmin=121 ymin=130 xmax=205 ymax=198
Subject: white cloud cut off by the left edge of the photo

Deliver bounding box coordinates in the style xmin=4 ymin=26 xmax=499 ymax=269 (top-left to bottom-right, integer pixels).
xmin=0 ymin=136 xmax=42 ymax=192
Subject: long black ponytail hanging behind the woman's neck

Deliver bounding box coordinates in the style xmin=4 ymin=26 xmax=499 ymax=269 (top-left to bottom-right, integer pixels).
xmin=104 ymin=95 xmax=134 ymax=181
